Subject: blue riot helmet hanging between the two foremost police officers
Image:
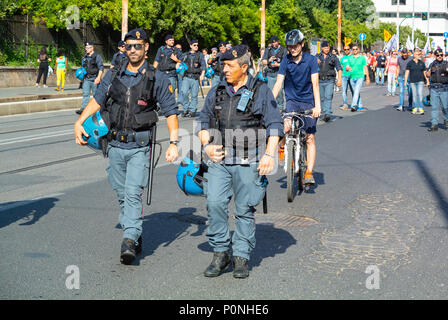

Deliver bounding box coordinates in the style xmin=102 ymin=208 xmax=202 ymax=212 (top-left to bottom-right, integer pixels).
xmin=176 ymin=157 xmax=207 ymax=196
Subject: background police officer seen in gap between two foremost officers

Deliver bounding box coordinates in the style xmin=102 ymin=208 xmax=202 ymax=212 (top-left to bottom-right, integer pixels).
xmin=181 ymin=39 xmax=206 ymax=118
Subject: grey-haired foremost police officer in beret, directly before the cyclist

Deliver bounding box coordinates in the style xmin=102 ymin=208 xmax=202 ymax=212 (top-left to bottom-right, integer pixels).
xmin=198 ymin=45 xmax=283 ymax=278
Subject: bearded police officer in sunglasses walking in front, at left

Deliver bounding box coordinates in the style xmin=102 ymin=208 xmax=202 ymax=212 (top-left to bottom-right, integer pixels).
xmin=74 ymin=29 xmax=178 ymax=264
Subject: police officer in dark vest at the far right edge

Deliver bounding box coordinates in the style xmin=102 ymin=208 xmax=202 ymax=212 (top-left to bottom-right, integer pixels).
xmin=426 ymin=49 xmax=448 ymax=131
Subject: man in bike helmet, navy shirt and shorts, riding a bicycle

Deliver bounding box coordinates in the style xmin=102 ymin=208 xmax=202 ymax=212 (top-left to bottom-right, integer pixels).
xmin=272 ymin=29 xmax=321 ymax=185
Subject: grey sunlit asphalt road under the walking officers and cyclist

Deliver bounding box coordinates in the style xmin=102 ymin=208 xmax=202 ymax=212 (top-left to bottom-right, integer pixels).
xmin=0 ymin=86 xmax=448 ymax=300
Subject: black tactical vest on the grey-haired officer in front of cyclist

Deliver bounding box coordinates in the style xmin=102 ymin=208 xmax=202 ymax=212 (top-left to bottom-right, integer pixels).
xmin=209 ymin=81 xmax=264 ymax=153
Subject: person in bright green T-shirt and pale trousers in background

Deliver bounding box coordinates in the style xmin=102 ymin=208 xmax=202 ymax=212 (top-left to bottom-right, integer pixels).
xmin=345 ymin=45 xmax=370 ymax=112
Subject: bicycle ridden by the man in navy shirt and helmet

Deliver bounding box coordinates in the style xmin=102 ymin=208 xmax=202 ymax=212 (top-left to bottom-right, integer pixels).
xmin=283 ymin=110 xmax=312 ymax=202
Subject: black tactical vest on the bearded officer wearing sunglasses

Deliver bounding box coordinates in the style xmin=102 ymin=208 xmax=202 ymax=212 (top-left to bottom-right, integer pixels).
xmin=101 ymin=66 xmax=158 ymax=132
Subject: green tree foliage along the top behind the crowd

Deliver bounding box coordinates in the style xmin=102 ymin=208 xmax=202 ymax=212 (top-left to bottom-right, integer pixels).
xmin=0 ymin=0 xmax=425 ymax=52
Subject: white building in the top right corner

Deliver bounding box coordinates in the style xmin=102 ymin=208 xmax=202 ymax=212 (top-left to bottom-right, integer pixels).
xmin=372 ymin=0 xmax=448 ymax=49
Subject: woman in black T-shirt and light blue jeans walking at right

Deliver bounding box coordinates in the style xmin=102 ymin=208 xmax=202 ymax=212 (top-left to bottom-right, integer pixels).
xmin=404 ymin=49 xmax=429 ymax=114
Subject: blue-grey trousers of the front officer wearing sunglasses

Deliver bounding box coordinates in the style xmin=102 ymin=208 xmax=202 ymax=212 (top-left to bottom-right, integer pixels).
xmin=106 ymin=145 xmax=149 ymax=241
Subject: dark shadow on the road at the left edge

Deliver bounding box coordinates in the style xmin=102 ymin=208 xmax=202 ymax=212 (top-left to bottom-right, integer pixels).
xmin=0 ymin=198 xmax=59 ymax=228
